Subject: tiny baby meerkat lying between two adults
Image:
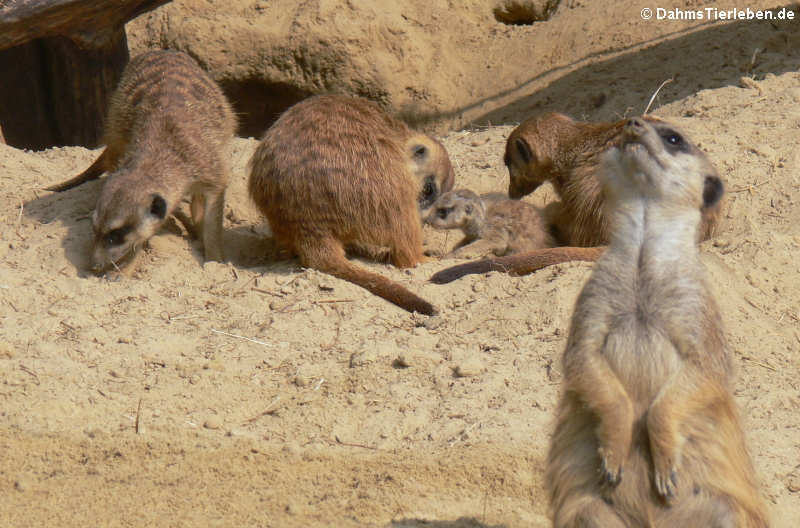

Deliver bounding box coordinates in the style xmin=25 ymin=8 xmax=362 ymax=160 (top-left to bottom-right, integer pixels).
xmin=425 ymin=189 xmax=554 ymax=258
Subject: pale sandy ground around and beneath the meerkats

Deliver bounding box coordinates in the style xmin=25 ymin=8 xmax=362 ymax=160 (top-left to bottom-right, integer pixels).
xmin=0 ymin=5 xmax=800 ymax=528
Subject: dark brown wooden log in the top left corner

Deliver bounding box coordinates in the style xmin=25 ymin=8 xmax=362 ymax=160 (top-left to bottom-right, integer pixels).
xmin=0 ymin=0 xmax=169 ymax=150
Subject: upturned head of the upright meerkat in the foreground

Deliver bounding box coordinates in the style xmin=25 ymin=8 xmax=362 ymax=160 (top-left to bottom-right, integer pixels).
xmin=603 ymin=117 xmax=724 ymax=209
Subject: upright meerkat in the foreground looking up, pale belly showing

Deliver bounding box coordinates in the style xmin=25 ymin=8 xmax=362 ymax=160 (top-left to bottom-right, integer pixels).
xmin=545 ymin=118 xmax=768 ymax=528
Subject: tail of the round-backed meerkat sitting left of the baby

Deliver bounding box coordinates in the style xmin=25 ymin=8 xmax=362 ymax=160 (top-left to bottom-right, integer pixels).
xmin=297 ymin=240 xmax=438 ymax=315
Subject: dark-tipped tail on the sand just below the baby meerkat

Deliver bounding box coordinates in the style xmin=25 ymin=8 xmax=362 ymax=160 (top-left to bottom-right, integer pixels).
xmin=430 ymin=246 xmax=605 ymax=284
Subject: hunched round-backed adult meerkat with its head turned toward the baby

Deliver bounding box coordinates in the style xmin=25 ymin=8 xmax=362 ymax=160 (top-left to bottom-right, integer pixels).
xmin=248 ymin=95 xmax=454 ymax=315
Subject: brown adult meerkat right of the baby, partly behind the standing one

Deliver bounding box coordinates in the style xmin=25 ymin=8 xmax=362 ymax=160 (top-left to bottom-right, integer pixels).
xmin=431 ymin=112 xmax=722 ymax=284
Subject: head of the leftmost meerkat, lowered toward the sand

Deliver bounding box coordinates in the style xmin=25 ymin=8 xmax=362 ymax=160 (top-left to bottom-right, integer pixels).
xmin=91 ymin=182 xmax=168 ymax=273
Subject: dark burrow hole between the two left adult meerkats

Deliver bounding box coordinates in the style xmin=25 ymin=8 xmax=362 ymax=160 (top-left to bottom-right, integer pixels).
xmin=219 ymin=79 xmax=312 ymax=138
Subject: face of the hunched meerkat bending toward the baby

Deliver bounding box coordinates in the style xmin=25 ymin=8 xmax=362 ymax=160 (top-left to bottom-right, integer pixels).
xmin=407 ymin=134 xmax=455 ymax=215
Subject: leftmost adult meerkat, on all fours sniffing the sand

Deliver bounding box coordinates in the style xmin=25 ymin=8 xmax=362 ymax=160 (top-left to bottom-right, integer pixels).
xmin=49 ymin=51 xmax=236 ymax=273
